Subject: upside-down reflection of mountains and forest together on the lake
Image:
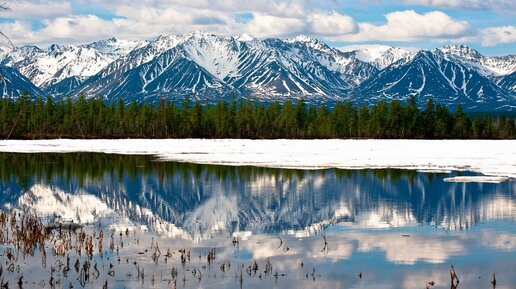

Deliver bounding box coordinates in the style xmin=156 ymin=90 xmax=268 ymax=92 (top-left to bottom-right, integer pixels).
xmin=0 ymin=153 xmax=516 ymax=239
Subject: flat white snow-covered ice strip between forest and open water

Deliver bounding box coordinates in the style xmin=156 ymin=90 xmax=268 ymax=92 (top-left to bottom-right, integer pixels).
xmin=0 ymin=139 xmax=516 ymax=178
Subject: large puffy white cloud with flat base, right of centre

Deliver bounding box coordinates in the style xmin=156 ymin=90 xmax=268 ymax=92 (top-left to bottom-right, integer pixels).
xmin=338 ymin=10 xmax=474 ymax=42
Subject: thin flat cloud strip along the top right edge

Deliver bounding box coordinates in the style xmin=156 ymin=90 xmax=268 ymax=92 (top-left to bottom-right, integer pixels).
xmin=403 ymin=0 xmax=516 ymax=13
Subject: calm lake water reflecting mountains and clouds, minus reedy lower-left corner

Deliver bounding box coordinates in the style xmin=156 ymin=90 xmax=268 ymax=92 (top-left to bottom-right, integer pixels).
xmin=0 ymin=153 xmax=516 ymax=288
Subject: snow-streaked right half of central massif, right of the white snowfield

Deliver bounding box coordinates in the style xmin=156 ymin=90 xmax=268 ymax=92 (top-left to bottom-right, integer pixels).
xmin=226 ymin=39 xmax=349 ymax=99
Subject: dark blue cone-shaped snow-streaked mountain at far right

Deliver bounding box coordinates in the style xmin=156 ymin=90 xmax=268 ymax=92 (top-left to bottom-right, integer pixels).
xmin=354 ymin=50 xmax=516 ymax=111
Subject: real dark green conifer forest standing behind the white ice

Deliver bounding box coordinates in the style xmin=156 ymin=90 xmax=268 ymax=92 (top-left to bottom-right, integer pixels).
xmin=0 ymin=94 xmax=516 ymax=139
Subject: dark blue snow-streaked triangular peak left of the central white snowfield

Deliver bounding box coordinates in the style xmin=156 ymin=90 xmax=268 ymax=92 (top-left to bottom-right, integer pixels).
xmin=73 ymin=47 xmax=230 ymax=102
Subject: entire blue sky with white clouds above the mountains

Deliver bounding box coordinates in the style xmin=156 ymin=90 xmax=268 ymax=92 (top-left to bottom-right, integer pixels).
xmin=0 ymin=0 xmax=516 ymax=55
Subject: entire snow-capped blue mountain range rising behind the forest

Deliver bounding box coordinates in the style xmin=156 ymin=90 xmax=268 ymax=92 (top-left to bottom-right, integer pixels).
xmin=0 ymin=31 xmax=516 ymax=111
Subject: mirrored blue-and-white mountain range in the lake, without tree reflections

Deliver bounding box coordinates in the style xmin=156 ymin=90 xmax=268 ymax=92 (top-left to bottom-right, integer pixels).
xmin=6 ymin=165 xmax=515 ymax=240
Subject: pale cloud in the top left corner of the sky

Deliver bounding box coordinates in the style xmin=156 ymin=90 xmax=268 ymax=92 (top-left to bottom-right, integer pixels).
xmin=0 ymin=0 xmax=72 ymax=19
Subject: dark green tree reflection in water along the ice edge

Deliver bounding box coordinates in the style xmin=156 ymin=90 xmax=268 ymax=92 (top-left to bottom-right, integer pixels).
xmin=0 ymin=153 xmax=416 ymax=192
